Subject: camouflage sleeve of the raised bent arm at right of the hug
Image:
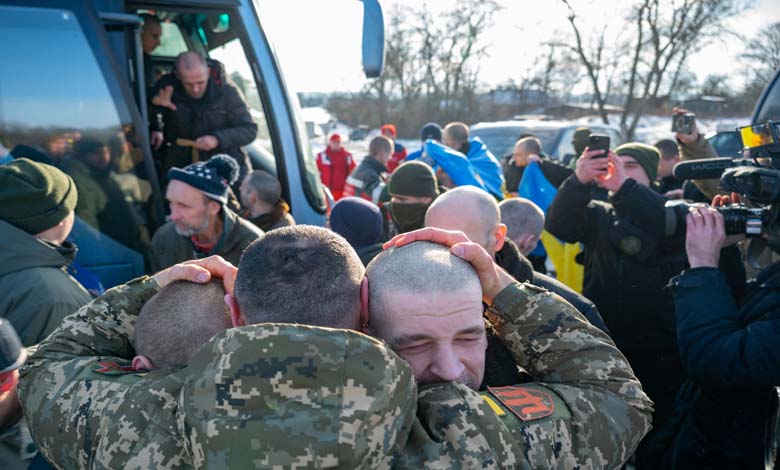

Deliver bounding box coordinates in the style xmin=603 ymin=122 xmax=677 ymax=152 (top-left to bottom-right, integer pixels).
xmin=488 ymin=283 xmax=652 ymax=468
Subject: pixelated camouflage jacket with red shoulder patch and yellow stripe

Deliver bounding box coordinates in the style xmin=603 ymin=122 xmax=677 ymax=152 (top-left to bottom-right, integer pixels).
xmin=397 ymin=283 xmax=652 ymax=469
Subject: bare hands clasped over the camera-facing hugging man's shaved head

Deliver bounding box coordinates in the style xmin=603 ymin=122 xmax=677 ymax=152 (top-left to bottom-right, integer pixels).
xmin=384 ymin=227 xmax=514 ymax=305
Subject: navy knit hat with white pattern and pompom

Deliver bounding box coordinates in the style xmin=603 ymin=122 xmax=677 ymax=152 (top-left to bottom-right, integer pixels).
xmin=168 ymin=153 xmax=239 ymax=204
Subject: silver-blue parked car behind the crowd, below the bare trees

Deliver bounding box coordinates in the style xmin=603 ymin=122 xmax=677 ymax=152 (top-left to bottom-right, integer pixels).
xmin=470 ymin=120 xmax=623 ymax=162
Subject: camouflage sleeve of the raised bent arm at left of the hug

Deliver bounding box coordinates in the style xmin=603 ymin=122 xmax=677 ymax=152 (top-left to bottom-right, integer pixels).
xmin=18 ymin=277 xmax=158 ymax=468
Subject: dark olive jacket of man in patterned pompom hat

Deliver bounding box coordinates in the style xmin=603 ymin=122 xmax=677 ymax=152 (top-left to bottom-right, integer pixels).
xmin=149 ymin=207 xmax=263 ymax=272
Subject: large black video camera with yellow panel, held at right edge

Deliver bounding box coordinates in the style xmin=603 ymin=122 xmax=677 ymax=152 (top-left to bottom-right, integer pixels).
xmin=674 ymin=121 xmax=780 ymax=246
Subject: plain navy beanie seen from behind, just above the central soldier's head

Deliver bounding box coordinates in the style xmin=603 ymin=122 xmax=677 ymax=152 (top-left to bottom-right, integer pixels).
xmin=330 ymin=197 xmax=382 ymax=248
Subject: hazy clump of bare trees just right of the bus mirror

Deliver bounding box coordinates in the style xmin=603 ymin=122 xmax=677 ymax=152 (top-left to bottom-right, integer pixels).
xmin=332 ymin=0 xmax=500 ymax=135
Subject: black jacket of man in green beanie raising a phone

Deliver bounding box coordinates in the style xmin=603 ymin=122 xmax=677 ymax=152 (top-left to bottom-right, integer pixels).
xmin=546 ymin=175 xmax=686 ymax=440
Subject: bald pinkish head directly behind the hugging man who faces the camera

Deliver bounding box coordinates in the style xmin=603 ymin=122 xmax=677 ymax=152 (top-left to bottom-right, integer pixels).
xmin=425 ymin=186 xmax=501 ymax=254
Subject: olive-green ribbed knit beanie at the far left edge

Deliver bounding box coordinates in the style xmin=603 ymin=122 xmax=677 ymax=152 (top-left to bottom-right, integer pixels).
xmin=0 ymin=158 xmax=78 ymax=235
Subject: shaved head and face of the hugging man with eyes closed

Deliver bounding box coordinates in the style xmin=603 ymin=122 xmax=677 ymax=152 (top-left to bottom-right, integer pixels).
xmin=366 ymin=242 xmax=487 ymax=389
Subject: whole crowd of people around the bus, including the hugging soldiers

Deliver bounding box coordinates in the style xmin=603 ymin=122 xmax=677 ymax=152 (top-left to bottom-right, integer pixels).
xmin=0 ymin=11 xmax=780 ymax=469
